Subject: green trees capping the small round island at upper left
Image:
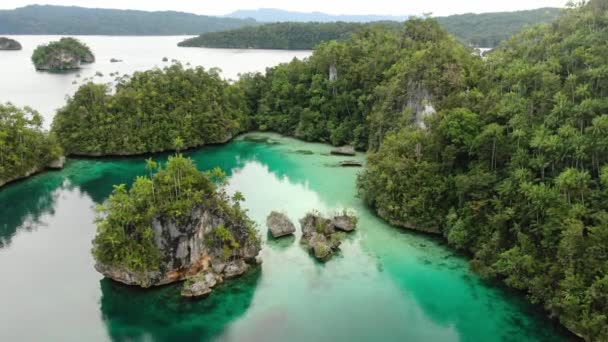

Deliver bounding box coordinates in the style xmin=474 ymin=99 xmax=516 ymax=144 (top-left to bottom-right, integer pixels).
xmin=32 ymin=37 xmax=95 ymax=70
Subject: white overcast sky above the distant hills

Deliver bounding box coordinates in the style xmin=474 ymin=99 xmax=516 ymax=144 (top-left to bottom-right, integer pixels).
xmin=0 ymin=0 xmax=567 ymax=15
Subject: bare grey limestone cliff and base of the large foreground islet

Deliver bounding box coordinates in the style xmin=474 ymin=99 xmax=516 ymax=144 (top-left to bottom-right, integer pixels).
xmin=95 ymin=207 xmax=261 ymax=287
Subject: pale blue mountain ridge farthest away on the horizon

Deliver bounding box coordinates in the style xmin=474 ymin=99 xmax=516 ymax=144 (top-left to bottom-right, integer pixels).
xmin=226 ymin=8 xmax=410 ymax=23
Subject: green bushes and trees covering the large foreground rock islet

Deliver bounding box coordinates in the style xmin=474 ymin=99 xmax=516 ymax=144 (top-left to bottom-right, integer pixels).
xmin=93 ymin=154 xmax=260 ymax=272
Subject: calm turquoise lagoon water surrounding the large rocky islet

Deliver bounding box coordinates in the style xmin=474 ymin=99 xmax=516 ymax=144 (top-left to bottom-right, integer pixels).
xmin=0 ymin=134 xmax=571 ymax=342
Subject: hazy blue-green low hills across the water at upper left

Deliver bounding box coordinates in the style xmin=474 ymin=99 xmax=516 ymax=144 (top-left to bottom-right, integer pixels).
xmin=0 ymin=5 xmax=256 ymax=35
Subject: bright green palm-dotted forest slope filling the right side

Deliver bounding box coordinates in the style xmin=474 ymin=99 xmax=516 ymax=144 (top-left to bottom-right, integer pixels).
xmin=359 ymin=0 xmax=608 ymax=341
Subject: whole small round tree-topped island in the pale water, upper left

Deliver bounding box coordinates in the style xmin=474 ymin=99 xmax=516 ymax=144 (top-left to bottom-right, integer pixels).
xmin=32 ymin=38 xmax=95 ymax=71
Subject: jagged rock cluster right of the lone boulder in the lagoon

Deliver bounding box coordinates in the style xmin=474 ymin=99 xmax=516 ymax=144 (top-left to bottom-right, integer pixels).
xmin=300 ymin=213 xmax=357 ymax=261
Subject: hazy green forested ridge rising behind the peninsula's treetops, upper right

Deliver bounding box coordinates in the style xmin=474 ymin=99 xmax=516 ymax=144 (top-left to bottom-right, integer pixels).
xmin=179 ymin=8 xmax=561 ymax=49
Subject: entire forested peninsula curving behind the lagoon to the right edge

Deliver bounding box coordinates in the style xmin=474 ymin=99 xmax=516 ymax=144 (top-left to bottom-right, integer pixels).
xmin=8 ymin=0 xmax=608 ymax=341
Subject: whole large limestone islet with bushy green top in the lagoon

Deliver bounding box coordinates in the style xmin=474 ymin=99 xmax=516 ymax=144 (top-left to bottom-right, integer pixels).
xmin=93 ymin=155 xmax=261 ymax=297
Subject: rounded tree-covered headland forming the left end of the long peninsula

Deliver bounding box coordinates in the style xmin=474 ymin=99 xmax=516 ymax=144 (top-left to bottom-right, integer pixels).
xmin=52 ymin=64 xmax=248 ymax=155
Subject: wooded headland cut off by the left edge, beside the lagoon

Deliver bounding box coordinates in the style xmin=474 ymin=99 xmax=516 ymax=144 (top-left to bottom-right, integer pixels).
xmin=0 ymin=103 xmax=63 ymax=186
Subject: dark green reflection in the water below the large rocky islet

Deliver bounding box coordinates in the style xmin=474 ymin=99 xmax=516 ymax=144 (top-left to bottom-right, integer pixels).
xmin=100 ymin=268 xmax=261 ymax=341
